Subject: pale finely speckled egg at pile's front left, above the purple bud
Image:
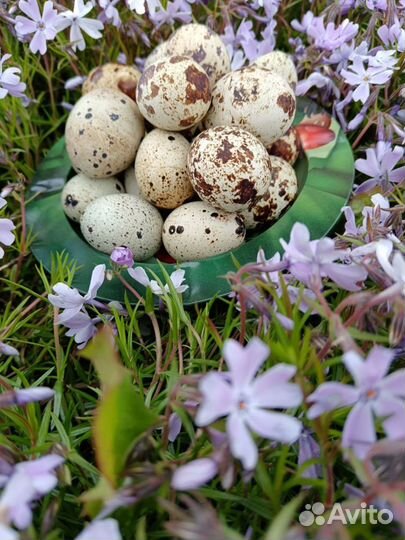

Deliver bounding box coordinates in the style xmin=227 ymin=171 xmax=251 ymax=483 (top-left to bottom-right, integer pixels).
xmin=80 ymin=193 xmax=163 ymax=261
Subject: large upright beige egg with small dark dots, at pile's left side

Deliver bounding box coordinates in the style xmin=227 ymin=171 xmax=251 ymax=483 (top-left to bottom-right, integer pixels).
xmin=65 ymin=88 xmax=144 ymax=178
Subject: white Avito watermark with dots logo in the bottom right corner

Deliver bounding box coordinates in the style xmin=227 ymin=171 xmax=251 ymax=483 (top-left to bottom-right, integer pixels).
xmin=298 ymin=502 xmax=394 ymax=527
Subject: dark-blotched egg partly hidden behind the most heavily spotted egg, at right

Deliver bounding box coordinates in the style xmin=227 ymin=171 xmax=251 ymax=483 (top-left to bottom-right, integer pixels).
xmin=240 ymin=156 xmax=298 ymax=229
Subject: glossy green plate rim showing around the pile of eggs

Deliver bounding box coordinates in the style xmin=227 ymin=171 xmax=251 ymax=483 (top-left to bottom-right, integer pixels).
xmin=27 ymin=98 xmax=354 ymax=304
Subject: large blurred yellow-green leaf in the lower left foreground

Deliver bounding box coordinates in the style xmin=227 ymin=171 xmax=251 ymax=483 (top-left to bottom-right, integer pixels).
xmin=93 ymin=376 xmax=157 ymax=486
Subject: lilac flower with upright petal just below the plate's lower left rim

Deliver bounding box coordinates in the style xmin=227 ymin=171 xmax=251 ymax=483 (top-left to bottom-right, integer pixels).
xmin=48 ymin=264 xmax=105 ymax=324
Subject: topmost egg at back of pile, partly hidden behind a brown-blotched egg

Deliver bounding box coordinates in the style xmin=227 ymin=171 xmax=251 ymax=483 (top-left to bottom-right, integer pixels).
xmin=167 ymin=23 xmax=231 ymax=84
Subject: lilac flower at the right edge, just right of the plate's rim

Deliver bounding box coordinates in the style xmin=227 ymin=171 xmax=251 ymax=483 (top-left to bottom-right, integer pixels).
xmin=355 ymin=141 xmax=405 ymax=193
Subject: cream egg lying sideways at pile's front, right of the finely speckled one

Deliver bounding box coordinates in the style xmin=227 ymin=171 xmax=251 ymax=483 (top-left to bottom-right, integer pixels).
xmin=163 ymin=201 xmax=246 ymax=262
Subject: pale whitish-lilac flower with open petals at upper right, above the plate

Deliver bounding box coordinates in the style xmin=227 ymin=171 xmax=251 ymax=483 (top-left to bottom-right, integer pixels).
xmin=341 ymin=56 xmax=393 ymax=103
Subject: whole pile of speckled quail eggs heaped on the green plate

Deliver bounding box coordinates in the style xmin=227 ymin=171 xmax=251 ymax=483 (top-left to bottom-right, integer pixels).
xmin=62 ymin=24 xmax=299 ymax=262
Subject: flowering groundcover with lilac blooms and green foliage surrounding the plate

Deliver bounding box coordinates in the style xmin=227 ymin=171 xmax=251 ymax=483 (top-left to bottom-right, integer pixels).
xmin=0 ymin=0 xmax=405 ymax=540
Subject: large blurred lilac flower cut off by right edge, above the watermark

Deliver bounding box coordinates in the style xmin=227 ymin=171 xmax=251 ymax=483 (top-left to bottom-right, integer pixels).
xmin=307 ymin=346 xmax=405 ymax=459
